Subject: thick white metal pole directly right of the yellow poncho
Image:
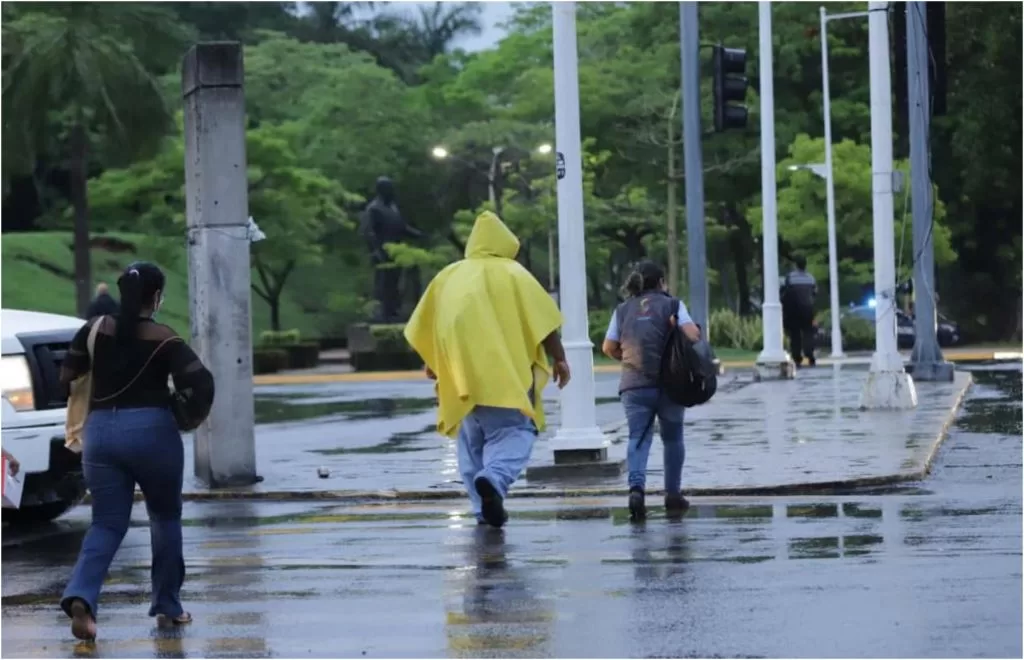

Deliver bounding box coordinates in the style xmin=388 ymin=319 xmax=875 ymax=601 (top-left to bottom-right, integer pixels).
xmin=552 ymin=2 xmax=607 ymax=464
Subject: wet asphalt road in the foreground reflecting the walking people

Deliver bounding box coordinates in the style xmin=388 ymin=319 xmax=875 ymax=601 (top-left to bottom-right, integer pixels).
xmin=0 ymin=364 xmax=1022 ymax=657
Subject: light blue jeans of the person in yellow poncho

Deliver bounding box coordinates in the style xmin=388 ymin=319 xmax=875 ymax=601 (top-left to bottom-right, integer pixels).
xmin=458 ymin=405 xmax=537 ymax=520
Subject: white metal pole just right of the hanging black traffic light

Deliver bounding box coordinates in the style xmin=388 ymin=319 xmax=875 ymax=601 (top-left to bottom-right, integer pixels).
xmin=757 ymin=2 xmax=796 ymax=379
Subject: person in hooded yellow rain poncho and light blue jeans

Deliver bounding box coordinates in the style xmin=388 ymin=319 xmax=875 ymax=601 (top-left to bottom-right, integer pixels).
xmin=406 ymin=211 xmax=569 ymax=527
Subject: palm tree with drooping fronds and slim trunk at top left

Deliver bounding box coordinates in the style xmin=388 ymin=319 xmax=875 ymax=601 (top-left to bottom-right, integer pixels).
xmin=2 ymin=2 xmax=188 ymax=314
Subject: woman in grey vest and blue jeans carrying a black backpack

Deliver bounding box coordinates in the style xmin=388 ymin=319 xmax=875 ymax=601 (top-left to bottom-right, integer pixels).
xmin=601 ymin=261 xmax=700 ymax=520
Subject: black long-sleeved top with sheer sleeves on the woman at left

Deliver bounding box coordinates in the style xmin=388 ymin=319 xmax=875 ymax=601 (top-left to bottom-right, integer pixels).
xmin=60 ymin=316 xmax=214 ymax=417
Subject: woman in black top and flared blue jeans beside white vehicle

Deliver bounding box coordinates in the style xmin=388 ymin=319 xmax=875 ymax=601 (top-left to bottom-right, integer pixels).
xmin=60 ymin=262 xmax=213 ymax=640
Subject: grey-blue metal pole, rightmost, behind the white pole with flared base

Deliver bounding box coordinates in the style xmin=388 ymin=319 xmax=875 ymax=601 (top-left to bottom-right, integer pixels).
xmin=906 ymin=2 xmax=953 ymax=381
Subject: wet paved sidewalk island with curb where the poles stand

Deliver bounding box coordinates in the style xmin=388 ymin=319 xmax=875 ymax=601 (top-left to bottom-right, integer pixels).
xmin=176 ymin=365 xmax=971 ymax=500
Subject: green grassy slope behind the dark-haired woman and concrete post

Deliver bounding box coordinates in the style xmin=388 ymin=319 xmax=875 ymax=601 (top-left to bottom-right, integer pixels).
xmin=0 ymin=231 xmax=319 ymax=340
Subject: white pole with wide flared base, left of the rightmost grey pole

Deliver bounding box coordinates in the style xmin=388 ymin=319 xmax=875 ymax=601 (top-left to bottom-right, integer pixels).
xmin=860 ymin=2 xmax=918 ymax=409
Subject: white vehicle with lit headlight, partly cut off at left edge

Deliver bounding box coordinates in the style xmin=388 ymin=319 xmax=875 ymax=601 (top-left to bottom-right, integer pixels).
xmin=0 ymin=309 xmax=85 ymax=524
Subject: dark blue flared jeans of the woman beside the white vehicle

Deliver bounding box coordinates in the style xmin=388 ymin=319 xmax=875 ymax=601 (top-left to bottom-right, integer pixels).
xmin=60 ymin=408 xmax=185 ymax=617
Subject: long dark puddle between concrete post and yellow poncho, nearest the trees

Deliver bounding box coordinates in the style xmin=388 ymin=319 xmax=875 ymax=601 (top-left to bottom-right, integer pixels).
xmin=256 ymin=394 xmax=437 ymax=424
